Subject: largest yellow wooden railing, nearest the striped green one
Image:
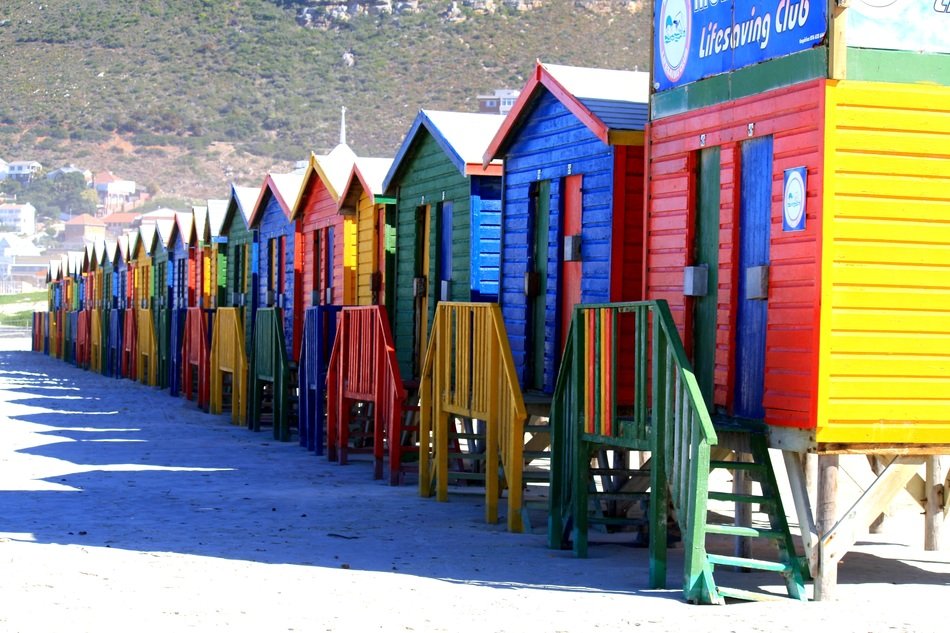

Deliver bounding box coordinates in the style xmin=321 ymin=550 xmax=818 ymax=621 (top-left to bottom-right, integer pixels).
xmin=419 ymin=302 xmax=527 ymax=532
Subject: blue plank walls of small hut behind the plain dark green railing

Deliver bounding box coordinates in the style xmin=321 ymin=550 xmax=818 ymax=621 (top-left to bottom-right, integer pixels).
xmin=252 ymin=187 xmax=303 ymax=359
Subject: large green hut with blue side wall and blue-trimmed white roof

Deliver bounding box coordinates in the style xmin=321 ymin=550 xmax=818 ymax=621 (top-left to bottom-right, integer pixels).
xmin=383 ymin=110 xmax=504 ymax=377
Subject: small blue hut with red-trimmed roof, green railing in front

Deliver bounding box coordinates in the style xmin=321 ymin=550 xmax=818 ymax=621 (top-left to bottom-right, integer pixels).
xmin=248 ymin=173 xmax=303 ymax=441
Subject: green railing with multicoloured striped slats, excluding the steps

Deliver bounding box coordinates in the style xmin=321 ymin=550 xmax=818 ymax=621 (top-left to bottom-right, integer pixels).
xmin=548 ymin=301 xmax=718 ymax=601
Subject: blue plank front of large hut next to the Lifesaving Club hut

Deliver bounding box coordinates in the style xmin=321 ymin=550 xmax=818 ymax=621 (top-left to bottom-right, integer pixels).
xmin=500 ymin=91 xmax=642 ymax=392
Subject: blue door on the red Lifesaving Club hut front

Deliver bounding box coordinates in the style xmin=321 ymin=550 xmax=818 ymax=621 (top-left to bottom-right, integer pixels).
xmin=733 ymin=136 xmax=772 ymax=419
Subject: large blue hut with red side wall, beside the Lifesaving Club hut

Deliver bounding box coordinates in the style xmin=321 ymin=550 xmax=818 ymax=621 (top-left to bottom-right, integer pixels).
xmin=485 ymin=61 xmax=650 ymax=393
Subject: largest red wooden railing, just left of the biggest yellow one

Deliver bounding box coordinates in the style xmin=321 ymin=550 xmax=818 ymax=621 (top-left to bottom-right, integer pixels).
xmin=327 ymin=306 xmax=406 ymax=486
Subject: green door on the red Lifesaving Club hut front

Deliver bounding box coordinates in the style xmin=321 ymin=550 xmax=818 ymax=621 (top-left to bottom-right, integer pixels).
xmin=692 ymin=147 xmax=720 ymax=412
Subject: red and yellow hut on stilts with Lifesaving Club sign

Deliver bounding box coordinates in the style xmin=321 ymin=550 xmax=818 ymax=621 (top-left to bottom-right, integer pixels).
xmin=645 ymin=1 xmax=950 ymax=601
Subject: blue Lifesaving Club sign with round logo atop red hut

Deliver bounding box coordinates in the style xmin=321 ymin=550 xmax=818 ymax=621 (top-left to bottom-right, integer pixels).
xmin=653 ymin=0 xmax=828 ymax=90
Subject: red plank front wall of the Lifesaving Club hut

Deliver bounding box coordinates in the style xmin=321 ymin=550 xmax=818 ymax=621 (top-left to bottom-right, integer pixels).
xmin=645 ymin=80 xmax=824 ymax=428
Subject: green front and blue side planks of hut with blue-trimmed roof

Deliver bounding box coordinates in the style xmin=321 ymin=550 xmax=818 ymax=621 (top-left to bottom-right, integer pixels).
xmin=387 ymin=128 xmax=499 ymax=376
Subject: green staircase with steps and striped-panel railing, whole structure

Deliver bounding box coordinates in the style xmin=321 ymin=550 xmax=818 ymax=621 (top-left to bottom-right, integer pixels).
xmin=548 ymin=301 xmax=807 ymax=604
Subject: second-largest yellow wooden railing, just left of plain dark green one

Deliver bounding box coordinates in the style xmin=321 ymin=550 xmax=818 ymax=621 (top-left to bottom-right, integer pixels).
xmin=209 ymin=308 xmax=247 ymax=424
